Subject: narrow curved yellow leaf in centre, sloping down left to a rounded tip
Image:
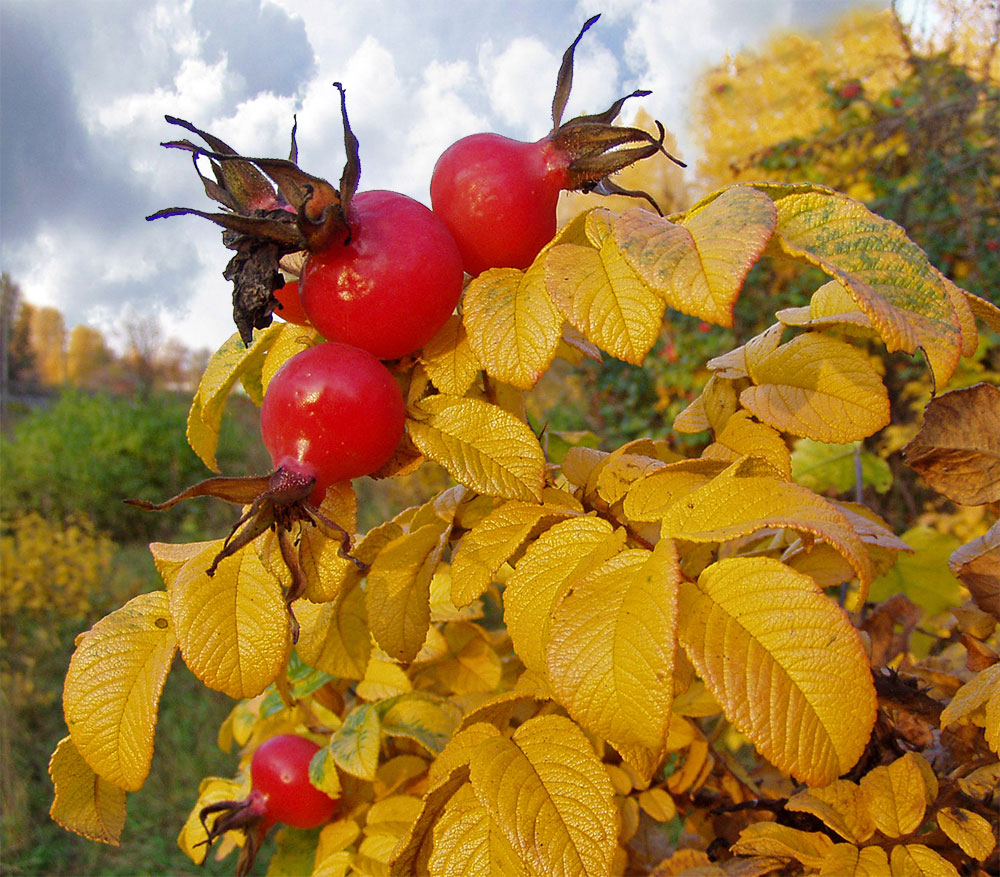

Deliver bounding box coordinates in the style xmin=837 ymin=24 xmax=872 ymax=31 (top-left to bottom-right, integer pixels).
xmin=451 ymin=502 xmax=569 ymax=606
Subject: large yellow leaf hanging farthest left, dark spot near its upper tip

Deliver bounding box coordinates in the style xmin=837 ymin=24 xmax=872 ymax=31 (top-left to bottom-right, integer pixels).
xmin=63 ymin=591 xmax=177 ymax=792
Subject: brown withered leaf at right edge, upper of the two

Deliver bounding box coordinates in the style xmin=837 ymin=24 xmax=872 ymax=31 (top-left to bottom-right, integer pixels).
xmin=903 ymin=383 xmax=1000 ymax=505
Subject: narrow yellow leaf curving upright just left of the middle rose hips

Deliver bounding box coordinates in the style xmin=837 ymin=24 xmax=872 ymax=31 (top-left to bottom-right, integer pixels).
xmin=187 ymin=323 xmax=285 ymax=472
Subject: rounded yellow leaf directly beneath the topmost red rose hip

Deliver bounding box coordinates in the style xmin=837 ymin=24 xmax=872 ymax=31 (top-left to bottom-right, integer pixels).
xmin=462 ymin=259 xmax=563 ymax=390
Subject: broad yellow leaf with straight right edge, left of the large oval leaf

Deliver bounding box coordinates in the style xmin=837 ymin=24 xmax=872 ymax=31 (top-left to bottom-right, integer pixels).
xmin=545 ymin=539 xmax=680 ymax=766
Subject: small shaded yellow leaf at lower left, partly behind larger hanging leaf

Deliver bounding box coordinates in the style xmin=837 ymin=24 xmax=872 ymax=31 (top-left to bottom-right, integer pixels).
xmin=49 ymin=737 xmax=125 ymax=846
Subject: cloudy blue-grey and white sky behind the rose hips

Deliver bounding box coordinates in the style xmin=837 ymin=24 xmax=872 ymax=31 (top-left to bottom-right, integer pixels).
xmin=0 ymin=0 xmax=887 ymax=349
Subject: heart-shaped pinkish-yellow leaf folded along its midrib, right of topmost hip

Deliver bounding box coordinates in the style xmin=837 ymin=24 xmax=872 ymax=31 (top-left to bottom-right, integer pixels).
xmin=612 ymin=186 xmax=777 ymax=326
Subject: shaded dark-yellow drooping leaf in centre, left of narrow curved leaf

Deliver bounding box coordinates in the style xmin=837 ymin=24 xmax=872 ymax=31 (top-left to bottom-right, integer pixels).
xmin=365 ymin=523 xmax=450 ymax=663
